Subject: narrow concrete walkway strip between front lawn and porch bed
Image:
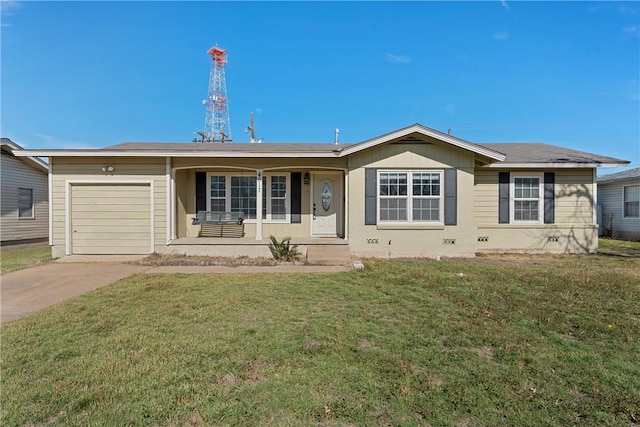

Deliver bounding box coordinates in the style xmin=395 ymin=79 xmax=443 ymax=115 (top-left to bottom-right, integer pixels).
xmin=145 ymin=264 xmax=352 ymax=274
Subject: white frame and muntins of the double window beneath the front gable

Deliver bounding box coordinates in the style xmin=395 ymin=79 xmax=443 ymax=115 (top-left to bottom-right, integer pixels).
xmin=376 ymin=169 xmax=444 ymax=225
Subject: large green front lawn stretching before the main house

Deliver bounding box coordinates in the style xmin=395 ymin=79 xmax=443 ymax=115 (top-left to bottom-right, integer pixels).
xmin=0 ymin=255 xmax=640 ymax=426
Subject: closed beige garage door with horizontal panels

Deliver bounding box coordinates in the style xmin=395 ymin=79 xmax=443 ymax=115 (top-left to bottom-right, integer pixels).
xmin=70 ymin=184 xmax=152 ymax=254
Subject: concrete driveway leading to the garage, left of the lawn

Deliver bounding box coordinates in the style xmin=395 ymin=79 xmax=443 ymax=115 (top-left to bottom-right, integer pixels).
xmin=0 ymin=262 xmax=148 ymax=322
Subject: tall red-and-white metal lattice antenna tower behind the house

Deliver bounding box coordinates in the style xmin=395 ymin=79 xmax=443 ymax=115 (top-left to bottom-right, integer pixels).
xmin=198 ymin=46 xmax=231 ymax=142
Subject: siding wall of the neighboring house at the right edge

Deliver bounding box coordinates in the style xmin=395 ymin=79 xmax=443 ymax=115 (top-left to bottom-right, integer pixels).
xmin=598 ymin=180 xmax=640 ymax=240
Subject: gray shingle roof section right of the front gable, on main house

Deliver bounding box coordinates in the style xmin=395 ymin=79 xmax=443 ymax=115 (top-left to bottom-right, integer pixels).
xmin=480 ymin=143 xmax=628 ymax=164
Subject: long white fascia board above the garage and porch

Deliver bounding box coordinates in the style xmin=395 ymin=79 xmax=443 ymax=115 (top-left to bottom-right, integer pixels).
xmin=15 ymin=150 xmax=341 ymax=158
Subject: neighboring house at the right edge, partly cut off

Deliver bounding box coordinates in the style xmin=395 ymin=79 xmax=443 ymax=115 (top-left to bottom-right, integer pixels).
xmin=598 ymin=168 xmax=640 ymax=240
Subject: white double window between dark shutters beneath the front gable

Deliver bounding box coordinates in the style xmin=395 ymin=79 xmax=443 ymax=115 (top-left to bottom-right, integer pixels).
xmin=378 ymin=171 xmax=442 ymax=223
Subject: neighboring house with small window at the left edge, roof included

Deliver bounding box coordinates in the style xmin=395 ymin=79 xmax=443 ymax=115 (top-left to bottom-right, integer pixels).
xmin=0 ymin=138 xmax=49 ymax=246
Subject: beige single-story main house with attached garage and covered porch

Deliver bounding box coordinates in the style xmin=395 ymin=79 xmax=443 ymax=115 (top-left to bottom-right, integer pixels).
xmin=16 ymin=124 xmax=629 ymax=258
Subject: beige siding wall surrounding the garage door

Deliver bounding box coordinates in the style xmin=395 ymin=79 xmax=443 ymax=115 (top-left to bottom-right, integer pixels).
xmin=51 ymin=157 xmax=167 ymax=257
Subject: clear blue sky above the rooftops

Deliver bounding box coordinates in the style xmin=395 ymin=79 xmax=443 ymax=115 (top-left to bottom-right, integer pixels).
xmin=0 ymin=1 xmax=640 ymax=174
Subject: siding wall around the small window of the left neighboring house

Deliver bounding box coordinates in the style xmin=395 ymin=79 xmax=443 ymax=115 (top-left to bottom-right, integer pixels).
xmin=0 ymin=151 xmax=49 ymax=243
